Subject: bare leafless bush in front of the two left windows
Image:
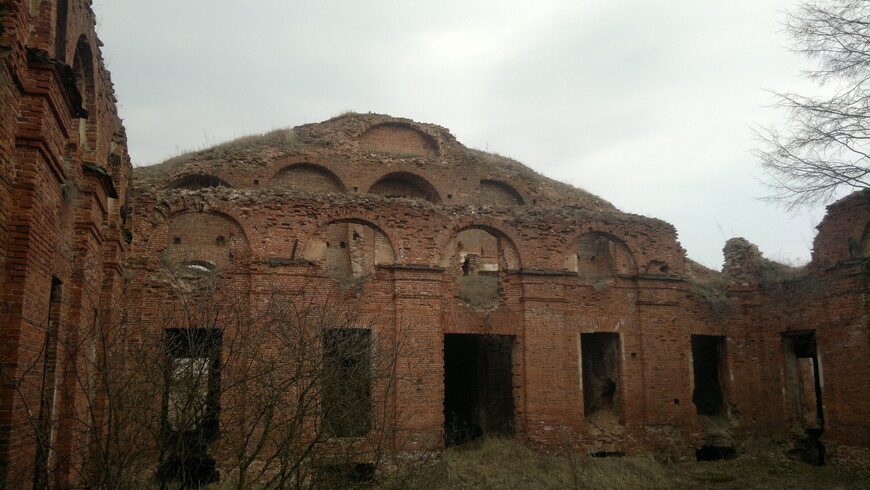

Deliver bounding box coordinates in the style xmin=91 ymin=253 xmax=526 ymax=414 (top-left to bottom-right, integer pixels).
xmin=7 ymin=258 xmax=416 ymax=488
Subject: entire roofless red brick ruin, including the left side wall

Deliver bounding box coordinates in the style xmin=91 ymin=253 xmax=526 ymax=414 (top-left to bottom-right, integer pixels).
xmin=0 ymin=0 xmax=870 ymax=486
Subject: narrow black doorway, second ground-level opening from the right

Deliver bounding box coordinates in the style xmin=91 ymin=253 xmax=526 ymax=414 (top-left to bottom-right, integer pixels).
xmin=692 ymin=335 xmax=725 ymax=416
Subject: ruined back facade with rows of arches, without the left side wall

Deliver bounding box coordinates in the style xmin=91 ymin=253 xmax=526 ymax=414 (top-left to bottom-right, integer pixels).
xmin=124 ymin=114 xmax=870 ymax=470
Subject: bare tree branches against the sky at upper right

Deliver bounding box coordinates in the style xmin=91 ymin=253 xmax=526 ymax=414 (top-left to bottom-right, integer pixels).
xmin=754 ymin=0 xmax=870 ymax=210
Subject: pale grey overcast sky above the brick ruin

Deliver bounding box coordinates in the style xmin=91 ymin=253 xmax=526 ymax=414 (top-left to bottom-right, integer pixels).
xmin=94 ymin=0 xmax=840 ymax=269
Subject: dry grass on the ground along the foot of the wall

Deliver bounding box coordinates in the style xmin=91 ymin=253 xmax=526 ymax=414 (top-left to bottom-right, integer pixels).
xmin=378 ymin=438 xmax=870 ymax=490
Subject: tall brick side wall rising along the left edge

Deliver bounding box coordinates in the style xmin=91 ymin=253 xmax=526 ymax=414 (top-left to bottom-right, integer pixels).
xmin=0 ymin=0 xmax=130 ymax=488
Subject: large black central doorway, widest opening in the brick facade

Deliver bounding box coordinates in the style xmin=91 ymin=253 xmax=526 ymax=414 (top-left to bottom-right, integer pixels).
xmin=444 ymin=334 xmax=514 ymax=446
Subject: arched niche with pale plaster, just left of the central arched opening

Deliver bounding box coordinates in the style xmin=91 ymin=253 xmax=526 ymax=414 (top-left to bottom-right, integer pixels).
xmin=304 ymin=220 xmax=395 ymax=282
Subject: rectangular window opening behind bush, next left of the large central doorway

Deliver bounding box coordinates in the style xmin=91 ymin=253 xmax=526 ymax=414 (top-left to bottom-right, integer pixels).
xmin=321 ymin=328 xmax=372 ymax=437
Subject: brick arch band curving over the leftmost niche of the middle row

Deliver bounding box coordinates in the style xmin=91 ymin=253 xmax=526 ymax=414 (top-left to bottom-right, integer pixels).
xmin=137 ymin=195 xmax=263 ymax=256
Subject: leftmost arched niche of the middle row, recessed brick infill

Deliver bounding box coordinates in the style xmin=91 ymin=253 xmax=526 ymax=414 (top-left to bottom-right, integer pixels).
xmin=162 ymin=212 xmax=250 ymax=278
